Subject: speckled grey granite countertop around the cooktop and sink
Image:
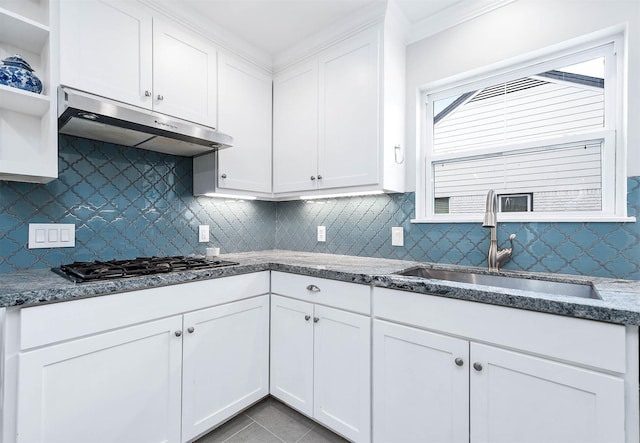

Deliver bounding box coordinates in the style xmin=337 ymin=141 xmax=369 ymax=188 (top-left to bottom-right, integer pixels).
xmin=0 ymin=251 xmax=640 ymax=326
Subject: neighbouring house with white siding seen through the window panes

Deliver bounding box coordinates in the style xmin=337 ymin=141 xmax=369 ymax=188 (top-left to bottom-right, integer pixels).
xmin=433 ymin=57 xmax=605 ymax=213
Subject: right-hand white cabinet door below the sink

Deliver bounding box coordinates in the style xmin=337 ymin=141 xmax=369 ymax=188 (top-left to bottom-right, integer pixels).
xmin=470 ymin=343 xmax=625 ymax=443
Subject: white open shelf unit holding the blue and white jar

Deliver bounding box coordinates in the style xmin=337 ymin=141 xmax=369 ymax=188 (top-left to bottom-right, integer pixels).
xmin=0 ymin=0 xmax=58 ymax=183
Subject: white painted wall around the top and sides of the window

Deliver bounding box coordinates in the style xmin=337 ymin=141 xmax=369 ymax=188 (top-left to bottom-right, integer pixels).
xmin=407 ymin=0 xmax=640 ymax=190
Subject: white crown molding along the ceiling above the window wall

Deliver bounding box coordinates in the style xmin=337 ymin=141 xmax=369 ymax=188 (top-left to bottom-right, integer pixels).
xmin=406 ymin=0 xmax=516 ymax=45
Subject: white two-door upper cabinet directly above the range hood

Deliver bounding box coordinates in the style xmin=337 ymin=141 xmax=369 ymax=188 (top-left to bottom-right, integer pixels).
xmin=60 ymin=0 xmax=217 ymax=127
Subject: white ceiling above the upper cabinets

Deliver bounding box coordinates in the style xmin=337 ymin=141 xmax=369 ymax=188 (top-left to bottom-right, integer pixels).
xmin=162 ymin=0 xmax=462 ymax=56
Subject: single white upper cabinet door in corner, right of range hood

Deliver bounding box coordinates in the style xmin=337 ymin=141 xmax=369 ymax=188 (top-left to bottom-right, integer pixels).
xmin=218 ymin=53 xmax=272 ymax=193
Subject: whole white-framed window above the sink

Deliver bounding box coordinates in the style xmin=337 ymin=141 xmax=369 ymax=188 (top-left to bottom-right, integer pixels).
xmin=415 ymin=34 xmax=626 ymax=222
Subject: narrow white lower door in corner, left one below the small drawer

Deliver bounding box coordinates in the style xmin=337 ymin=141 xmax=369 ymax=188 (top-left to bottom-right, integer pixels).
xmin=271 ymin=295 xmax=313 ymax=416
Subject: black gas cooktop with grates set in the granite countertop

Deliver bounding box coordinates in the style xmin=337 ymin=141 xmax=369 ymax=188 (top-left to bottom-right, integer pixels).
xmin=52 ymin=256 xmax=238 ymax=283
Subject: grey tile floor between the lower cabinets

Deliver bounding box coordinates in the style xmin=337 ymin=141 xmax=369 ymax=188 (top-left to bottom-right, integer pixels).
xmin=195 ymin=397 xmax=347 ymax=443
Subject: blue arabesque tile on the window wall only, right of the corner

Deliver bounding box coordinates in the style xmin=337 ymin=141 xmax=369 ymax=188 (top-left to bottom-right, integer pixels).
xmin=276 ymin=177 xmax=640 ymax=280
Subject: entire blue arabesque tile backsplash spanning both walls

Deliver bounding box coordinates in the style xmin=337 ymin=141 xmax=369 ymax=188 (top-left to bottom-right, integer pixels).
xmin=0 ymin=136 xmax=640 ymax=280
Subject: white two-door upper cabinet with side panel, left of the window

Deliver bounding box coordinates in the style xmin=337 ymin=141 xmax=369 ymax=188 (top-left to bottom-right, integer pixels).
xmin=273 ymin=24 xmax=404 ymax=198
